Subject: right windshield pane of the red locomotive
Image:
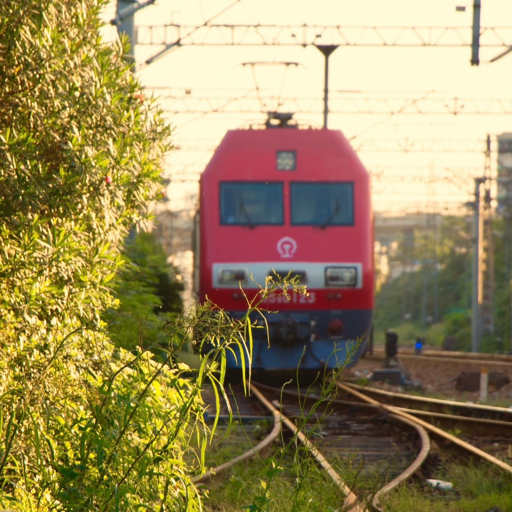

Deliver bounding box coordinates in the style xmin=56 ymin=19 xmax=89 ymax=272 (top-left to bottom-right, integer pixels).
xmin=290 ymin=182 xmax=354 ymax=229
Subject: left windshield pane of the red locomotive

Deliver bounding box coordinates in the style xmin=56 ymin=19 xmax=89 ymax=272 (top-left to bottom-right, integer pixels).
xmin=220 ymin=181 xmax=284 ymax=228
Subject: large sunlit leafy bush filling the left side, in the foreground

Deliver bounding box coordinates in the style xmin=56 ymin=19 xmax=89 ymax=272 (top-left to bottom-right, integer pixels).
xmin=0 ymin=0 xmax=210 ymax=511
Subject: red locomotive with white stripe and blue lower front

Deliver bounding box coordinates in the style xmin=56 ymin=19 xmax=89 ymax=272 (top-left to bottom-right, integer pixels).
xmin=195 ymin=120 xmax=374 ymax=371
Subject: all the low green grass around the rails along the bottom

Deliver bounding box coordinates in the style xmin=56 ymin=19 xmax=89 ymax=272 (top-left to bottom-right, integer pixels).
xmin=195 ymin=420 xmax=512 ymax=512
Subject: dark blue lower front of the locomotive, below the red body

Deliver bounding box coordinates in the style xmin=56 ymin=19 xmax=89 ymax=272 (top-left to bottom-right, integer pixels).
xmin=227 ymin=309 xmax=373 ymax=371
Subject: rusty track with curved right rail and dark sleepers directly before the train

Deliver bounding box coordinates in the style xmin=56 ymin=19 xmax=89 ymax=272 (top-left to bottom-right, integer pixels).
xmin=197 ymin=384 xmax=429 ymax=511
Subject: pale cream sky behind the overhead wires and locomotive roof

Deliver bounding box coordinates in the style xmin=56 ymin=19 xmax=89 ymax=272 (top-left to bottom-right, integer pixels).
xmin=105 ymin=0 xmax=512 ymax=215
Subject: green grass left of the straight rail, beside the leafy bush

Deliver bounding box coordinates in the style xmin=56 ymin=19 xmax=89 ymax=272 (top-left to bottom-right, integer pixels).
xmin=194 ymin=408 xmax=358 ymax=512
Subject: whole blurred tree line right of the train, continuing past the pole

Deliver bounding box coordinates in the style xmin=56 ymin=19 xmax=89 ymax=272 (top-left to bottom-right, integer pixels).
xmin=375 ymin=216 xmax=512 ymax=352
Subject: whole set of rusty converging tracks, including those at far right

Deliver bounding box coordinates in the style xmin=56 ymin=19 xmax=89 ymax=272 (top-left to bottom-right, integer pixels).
xmin=200 ymin=378 xmax=512 ymax=511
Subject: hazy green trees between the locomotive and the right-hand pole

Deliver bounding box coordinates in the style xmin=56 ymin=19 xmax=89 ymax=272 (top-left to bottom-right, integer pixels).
xmin=375 ymin=217 xmax=472 ymax=344
